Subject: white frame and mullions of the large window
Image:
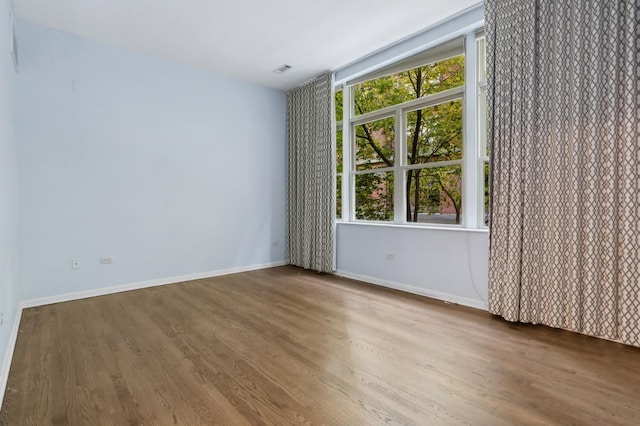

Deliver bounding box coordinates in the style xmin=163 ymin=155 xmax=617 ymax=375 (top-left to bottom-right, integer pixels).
xmin=336 ymin=29 xmax=489 ymax=229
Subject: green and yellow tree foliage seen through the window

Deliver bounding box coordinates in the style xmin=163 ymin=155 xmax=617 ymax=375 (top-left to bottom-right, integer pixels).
xmin=353 ymin=56 xmax=464 ymax=223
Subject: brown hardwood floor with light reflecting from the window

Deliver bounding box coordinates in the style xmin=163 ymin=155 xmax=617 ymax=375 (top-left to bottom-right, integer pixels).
xmin=0 ymin=267 xmax=640 ymax=425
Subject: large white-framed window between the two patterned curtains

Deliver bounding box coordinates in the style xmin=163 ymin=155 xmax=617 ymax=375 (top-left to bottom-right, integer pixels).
xmin=336 ymin=31 xmax=488 ymax=226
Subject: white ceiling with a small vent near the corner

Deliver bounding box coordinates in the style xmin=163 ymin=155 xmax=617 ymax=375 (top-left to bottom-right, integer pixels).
xmin=14 ymin=0 xmax=479 ymax=90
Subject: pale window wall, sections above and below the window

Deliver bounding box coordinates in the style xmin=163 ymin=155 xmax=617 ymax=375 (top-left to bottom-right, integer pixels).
xmin=336 ymin=4 xmax=489 ymax=309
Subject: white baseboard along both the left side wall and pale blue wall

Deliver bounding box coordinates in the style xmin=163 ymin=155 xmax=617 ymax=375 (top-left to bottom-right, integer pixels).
xmin=0 ymin=261 xmax=287 ymax=407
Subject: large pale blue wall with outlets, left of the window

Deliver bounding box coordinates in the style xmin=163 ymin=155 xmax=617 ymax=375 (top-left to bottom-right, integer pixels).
xmin=16 ymin=21 xmax=286 ymax=300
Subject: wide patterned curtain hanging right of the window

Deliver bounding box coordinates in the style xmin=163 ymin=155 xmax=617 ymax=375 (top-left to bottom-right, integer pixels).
xmin=485 ymin=0 xmax=640 ymax=346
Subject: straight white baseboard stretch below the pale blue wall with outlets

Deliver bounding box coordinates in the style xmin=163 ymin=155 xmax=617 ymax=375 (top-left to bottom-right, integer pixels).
xmin=20 ymin=261 xmax=287 ymax=309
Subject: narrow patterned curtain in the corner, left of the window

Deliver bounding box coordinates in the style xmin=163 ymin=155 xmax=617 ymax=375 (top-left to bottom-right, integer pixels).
xmin=287 ymin=74 xmax=335 ymax=272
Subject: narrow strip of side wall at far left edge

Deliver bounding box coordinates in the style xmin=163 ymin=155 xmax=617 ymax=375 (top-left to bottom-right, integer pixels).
xmin=0 ymin=0 xmax=18 ymax=403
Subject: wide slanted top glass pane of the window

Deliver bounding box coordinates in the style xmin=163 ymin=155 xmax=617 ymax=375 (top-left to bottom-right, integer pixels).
xmin=353 ymin=55 xmax=464 ymax=115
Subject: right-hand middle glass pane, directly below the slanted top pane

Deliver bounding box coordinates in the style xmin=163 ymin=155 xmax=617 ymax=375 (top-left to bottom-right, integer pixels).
xmin=407 ymin=99 xmax=462 ymax=164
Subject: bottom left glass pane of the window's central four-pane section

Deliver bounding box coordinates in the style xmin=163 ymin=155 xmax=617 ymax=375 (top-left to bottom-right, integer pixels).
xmin=355 ymin=172 xmax=393 ymax=220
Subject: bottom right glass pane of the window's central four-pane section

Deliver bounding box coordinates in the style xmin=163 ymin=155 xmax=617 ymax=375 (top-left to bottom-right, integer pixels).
xmin=405 ymin=165 xmax=462 ymax=224
